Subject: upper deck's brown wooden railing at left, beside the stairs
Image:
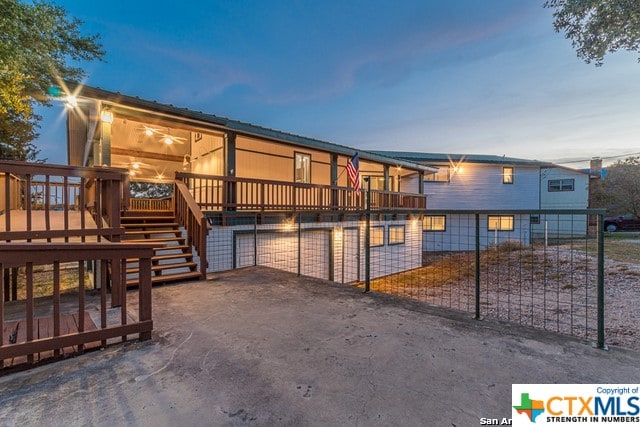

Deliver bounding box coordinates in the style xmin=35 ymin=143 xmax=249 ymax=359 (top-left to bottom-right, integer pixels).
xmin=0 ymin=161 xmax=127 ymax=304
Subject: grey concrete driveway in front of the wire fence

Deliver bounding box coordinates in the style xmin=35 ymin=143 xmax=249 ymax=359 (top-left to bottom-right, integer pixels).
xmin=0 ymin=267 xmax=640 ymax=426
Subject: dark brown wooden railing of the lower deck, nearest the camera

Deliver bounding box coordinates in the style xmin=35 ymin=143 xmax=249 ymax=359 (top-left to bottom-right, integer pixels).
xmin=0 ymin=242 xmax=153 ymax=368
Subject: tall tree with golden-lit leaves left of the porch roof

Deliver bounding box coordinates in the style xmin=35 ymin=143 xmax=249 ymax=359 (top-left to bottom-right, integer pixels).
xmin=0 ymin=0 xmax=104 ymax=160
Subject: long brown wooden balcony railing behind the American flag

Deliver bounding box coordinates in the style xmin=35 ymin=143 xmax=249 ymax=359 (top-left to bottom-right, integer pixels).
xmin=176 ymin=172 xmax=427 ymax=212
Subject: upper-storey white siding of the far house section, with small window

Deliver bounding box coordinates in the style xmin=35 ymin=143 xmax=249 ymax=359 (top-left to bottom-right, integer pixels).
xmin=424 ymin=163 xmax=540 ymax=209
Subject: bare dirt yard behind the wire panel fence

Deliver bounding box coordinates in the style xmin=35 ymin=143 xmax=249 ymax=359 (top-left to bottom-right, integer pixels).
xmin=358 ymin=243 xmax=640 ymax=350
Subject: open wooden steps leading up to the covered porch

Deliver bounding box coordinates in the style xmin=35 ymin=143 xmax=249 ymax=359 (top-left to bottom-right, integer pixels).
xmin=120 ymin=211 xmax=201 ymax=287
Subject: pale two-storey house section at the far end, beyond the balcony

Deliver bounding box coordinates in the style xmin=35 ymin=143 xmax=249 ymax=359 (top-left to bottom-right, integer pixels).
xmin=376 ymin=151 xmax=589 ymax=251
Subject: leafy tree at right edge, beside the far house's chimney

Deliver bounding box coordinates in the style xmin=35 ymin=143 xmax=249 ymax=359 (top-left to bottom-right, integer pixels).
xmin=602 ymin=157 xmax=640 ymax=216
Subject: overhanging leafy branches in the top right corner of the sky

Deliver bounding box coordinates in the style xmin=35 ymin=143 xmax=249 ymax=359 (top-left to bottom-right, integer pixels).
xmin=544 ymin=0 xmax=640 ymax=66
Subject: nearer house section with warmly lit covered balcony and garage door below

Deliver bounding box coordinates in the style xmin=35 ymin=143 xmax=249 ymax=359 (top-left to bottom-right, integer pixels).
xmin=65 ymin=85 xmax=436 ymax=282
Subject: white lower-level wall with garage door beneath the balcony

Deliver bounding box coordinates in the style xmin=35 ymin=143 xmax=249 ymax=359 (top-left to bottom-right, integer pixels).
xmin=207 ymin=219 xmax=422 ymax=283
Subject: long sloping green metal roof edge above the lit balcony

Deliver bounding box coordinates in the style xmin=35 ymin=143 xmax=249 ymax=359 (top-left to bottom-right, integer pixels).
xmin=66 ymin=82 xmax=437 ymax=173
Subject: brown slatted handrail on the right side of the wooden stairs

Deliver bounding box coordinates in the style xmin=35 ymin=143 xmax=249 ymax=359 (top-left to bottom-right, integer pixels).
xmin=174 ymin=180 xmax=209 ymax=279
